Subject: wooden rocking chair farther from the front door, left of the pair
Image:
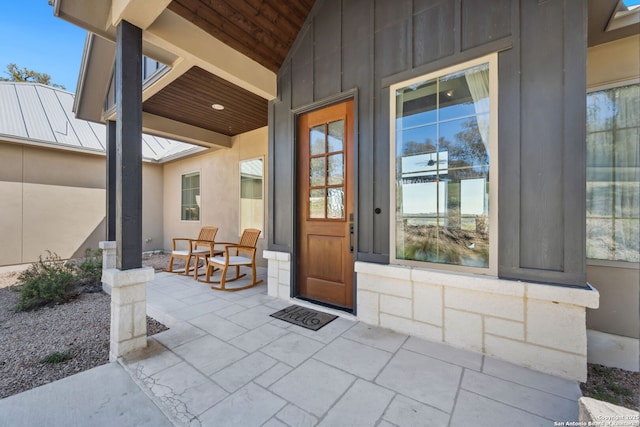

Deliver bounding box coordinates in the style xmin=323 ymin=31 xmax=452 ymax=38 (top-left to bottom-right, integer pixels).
xmin=165 ymin=227 xmax=224 ymax=279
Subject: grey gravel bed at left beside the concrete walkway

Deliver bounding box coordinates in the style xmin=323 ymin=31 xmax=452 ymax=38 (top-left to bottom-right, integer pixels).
xmin=0 ymin=258 xmax=167 ymax=399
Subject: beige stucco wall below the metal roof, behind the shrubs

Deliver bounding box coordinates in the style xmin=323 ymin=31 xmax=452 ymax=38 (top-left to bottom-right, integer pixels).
xmin=0 ymin=142 xmax=163 ymax=266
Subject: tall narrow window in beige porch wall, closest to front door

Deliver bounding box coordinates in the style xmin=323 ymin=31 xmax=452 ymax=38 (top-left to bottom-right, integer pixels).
xmin=240 ymin=159 xmax=264 ymax=231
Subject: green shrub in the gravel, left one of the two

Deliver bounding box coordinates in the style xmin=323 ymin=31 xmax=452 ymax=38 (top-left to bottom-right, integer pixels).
xmin=16 ymin=251 xmax=77 ymax=310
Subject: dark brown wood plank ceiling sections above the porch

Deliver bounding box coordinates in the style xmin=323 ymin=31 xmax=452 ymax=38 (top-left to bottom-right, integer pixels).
xmin=143 ymin=0 xmax=315 ymax=136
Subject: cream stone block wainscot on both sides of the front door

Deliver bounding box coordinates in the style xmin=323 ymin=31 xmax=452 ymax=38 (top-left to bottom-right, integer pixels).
xmin=264 ymin=251 xmax=599 ymax=381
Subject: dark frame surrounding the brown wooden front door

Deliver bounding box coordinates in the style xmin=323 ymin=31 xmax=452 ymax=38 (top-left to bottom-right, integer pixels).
xmin=289 ymin=88 xmax=359 ymax=315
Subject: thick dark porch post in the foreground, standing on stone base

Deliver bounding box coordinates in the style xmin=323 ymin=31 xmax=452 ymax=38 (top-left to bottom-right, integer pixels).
xmin=115 ymin=21 xmax=142 ymax=270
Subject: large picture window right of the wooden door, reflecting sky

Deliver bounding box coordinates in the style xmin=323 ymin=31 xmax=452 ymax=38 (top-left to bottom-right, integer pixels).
xmin=391 ymin=56 xmax=497 ymax=269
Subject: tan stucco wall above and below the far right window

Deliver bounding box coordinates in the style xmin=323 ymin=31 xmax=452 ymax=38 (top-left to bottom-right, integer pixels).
xmin=587 ymin=35 xmax=640 ymax=338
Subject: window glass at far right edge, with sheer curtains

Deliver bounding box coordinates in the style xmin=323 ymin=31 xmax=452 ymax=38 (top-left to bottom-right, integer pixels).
xmin=587 ymin=84 xmax=640 ymax=262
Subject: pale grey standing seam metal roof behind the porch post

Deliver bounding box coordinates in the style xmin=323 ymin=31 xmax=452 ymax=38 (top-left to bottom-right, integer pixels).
xmin=0 ymin=82 xmax=205 ymax=162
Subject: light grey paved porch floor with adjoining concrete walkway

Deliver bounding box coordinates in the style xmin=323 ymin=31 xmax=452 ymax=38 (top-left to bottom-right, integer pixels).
xmin=0 ymin=269 xmax=580 ymax=427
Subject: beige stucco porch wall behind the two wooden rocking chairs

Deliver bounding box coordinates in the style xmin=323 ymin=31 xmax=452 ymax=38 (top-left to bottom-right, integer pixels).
xmin=164 ymin=127 xmax=268 ymax=266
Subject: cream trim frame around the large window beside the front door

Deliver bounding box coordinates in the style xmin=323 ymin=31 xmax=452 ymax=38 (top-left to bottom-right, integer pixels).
xmin=389 ymin=52 xmax=499 ymax=276
